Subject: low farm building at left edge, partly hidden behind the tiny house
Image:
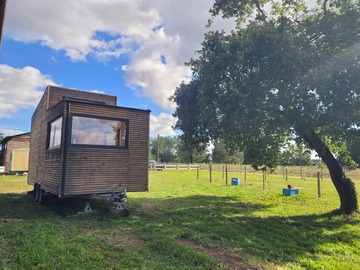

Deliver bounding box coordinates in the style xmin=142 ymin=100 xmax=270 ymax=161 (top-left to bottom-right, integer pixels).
xmin=0 ymin=132 xmax=30 ymax=173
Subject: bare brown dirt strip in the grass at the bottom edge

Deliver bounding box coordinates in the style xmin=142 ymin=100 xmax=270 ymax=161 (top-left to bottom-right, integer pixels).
xmin=178 ymin=239 xmax=264 ymax=270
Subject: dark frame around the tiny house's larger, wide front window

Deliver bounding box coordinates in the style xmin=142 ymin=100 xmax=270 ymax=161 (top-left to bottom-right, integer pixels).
xmin=69 ymin=114 xmax=129 ymax=149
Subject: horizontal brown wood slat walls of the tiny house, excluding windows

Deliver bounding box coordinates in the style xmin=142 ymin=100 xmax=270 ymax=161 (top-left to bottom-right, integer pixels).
xmin=28 ymin=86 xmax=150 ymax=196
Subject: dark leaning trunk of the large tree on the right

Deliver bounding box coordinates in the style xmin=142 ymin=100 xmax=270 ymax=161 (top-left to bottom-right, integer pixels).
xmin=299 ymin=131 xmax=358 ymax=214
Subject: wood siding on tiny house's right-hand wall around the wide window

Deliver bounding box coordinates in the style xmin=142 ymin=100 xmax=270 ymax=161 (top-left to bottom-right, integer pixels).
xmin=64 ymin=102 xmax=149 ymax=195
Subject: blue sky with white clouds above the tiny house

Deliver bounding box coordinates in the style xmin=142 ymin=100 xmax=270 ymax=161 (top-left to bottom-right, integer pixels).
xmin=0 ymin=0 xmax=234 ymax=136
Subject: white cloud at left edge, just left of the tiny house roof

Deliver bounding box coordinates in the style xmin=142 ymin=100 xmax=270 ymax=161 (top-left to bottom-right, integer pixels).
xmin=0 ymin=65 xmax=56 ymax=118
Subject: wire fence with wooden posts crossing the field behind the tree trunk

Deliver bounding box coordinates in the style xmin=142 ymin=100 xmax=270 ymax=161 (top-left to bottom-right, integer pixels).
xmin=153 ymin=164 xmax=360 ymax=198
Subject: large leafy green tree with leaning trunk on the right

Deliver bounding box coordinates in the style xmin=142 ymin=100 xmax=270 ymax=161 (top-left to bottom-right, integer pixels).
xmin=173 ymin=0 xmax=360 ymax=213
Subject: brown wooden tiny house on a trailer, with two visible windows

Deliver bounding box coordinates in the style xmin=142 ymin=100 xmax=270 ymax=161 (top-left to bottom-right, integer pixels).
xmin=28 ymin=86 xmax=150 ymax=197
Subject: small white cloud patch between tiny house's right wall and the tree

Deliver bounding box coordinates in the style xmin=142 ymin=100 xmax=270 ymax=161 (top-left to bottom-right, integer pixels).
xmin=150 ymin=113 xmax=176 ymax=136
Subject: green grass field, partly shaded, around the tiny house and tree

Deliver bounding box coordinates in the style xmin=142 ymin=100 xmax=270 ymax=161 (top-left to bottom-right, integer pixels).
xmin=0 ymin=170 xmax=360 ymax=270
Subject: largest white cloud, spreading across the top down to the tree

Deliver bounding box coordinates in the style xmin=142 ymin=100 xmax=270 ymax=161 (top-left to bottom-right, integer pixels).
xmin=5 ymin=0 xmax=234 ymax=110
